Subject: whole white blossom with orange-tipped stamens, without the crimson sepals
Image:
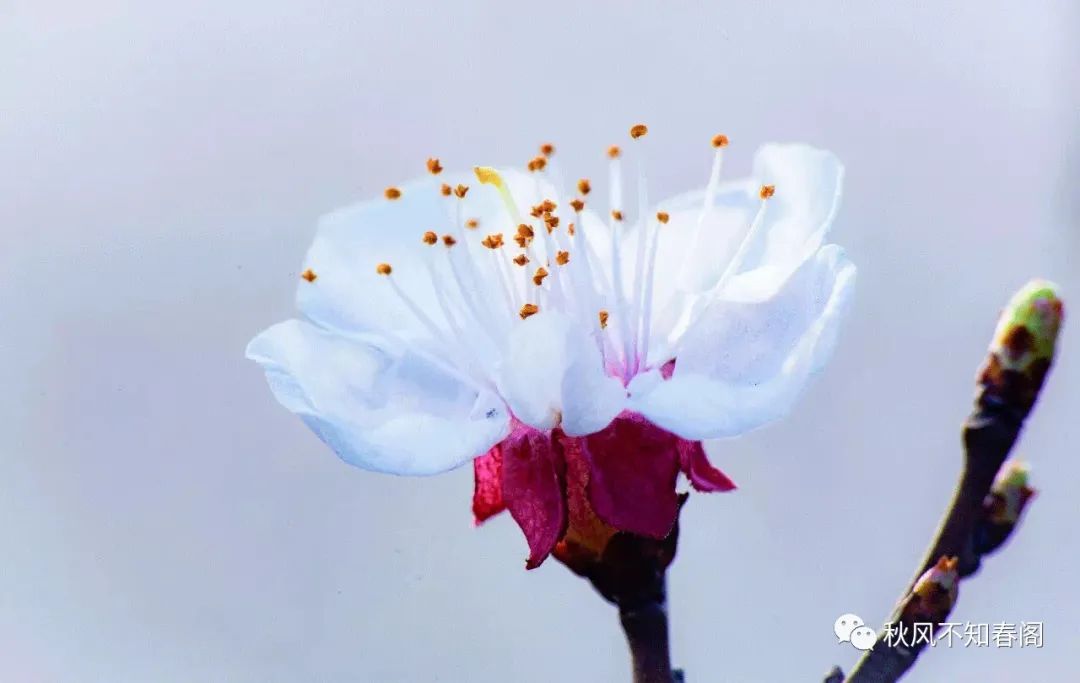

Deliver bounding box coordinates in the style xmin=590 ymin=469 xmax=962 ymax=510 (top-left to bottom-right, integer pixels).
xmin=247 ymin=126 xmax=855 ymax=474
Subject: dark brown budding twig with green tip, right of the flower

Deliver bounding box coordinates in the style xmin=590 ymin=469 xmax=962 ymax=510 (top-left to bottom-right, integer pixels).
xmin=825 ymin=282 xmax=1062 ymax=683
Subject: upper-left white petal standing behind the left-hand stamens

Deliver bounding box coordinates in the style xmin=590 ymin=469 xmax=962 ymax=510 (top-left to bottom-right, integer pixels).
xmin=297 ymin=170 xmax=548 ymax=340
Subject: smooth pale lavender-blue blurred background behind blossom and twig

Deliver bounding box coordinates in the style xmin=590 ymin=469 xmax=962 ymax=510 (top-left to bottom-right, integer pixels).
xmin=0 ymin=0 xmax=1080 ymax=683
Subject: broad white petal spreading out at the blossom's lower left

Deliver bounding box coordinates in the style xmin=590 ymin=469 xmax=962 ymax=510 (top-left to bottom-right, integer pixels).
xmin=247 ymin=320 xmax=510 ymax=474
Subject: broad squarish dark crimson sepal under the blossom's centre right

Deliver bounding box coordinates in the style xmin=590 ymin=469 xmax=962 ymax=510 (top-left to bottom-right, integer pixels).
xmin=581 ymin=412 xmax=679 ymax=538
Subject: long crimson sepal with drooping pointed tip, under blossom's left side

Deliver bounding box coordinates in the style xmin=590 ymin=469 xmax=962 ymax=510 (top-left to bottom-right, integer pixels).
xmin=500 ymin=424 xmax=567 ymax=570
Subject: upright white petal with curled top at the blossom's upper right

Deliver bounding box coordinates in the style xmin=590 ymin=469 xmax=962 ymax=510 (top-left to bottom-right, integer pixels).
xmin=725 ymin=144 xmax=843 ymax=302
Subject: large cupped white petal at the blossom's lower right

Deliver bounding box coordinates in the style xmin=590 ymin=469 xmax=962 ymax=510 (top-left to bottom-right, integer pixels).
xmin=631 ymin=245 xmax=855 ymax=439
